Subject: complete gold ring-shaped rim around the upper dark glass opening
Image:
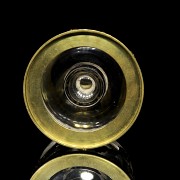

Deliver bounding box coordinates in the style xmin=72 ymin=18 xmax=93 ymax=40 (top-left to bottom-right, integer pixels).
xmin=23 ymin=29 xmax=144 ymax=149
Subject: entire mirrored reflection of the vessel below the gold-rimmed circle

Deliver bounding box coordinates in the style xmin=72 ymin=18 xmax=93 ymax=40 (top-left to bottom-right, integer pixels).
xmin=31 ymin=142 xmax=131 ymax=180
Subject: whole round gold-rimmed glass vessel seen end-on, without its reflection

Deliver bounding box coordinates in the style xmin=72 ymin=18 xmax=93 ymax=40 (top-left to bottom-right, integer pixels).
xmin=23 ymin=29 xmax=144 ymax=149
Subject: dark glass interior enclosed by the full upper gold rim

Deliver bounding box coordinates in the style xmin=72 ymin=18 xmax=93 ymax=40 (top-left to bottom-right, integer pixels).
xmin=41 ymin=47 xmax=126 ymax=131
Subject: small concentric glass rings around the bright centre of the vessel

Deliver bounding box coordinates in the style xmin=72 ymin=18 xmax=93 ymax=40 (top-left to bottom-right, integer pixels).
xmin=64 ymin=62 xmax=108 ymax=107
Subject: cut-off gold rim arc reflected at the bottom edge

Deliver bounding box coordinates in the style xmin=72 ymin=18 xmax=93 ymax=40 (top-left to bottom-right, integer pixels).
xmin=31 ymin=154 xmax=130 ymax=180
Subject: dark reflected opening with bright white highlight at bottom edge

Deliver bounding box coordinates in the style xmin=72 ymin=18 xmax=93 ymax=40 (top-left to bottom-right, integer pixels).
xmin=50 ymin=166 xmax=111 ymax=180
